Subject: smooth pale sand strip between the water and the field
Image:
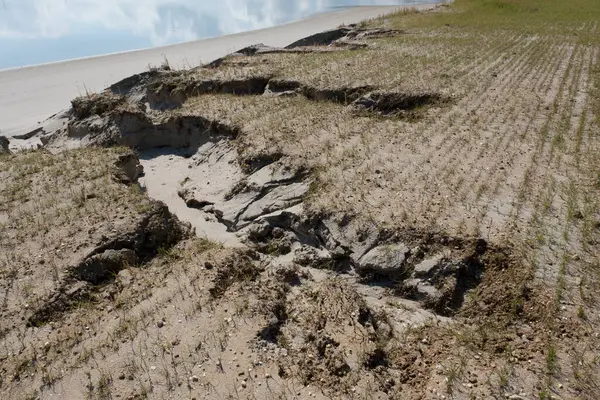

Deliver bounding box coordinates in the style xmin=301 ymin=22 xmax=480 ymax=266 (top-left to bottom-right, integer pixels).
xmin=0 ymin=5 xmax=432 ymax=136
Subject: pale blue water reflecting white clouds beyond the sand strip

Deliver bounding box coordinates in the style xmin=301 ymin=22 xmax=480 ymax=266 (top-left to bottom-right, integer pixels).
xmin=0 ymin=0 xmax=431 ymax=69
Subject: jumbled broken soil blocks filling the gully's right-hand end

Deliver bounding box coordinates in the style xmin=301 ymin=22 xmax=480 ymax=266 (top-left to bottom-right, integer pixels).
xmin=242 ymin=211 xmax=506 ymax=316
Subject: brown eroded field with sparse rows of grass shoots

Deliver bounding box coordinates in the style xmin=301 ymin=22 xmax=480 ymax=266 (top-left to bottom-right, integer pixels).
xmin=0 ymin=0 xmax=600 ymax=399
